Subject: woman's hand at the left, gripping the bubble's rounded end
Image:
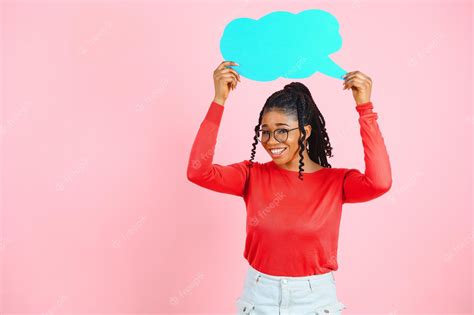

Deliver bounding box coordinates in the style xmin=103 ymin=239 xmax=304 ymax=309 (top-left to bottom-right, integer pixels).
xmin=214 ymin=61 xmax=240 ymax=105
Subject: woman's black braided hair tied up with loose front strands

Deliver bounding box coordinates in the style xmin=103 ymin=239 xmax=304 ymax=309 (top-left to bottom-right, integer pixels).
xmin=249 ymin=82 xmax=333 ymax=180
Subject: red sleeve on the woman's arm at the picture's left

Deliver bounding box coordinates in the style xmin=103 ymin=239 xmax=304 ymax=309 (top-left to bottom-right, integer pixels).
xmin=187 ymin=102 xmax=250 ymax=197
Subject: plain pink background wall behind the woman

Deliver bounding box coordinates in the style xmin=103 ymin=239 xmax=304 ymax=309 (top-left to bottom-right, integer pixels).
xmin=0 ymin=0 xmax=474 ymax=314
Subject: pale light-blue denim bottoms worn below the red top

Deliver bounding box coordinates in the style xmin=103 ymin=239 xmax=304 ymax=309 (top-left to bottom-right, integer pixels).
xmin=235 ymin=265 xmax=346 ymax=315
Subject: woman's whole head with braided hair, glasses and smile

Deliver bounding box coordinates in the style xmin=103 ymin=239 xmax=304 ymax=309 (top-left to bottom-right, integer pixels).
xmin=250 ymin=82 xmax=332 ymax=179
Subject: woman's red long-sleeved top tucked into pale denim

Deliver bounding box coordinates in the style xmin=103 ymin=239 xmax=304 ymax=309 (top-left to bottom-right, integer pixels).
xmin=187 ymin=102 xmax=392 ymax=277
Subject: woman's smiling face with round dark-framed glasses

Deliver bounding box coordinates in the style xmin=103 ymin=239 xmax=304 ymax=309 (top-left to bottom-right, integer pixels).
xmin=260 ymin=110 xmax=311 ymax=164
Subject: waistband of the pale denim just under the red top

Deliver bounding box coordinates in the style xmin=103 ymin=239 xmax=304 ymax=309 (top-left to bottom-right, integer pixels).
xmin=247 ymin=265 xmax=335 ymax=287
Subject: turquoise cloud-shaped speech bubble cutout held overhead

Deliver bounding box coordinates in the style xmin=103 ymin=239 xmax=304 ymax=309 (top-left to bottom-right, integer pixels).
xmin=220 ymin=9 xmax=347 ymax=81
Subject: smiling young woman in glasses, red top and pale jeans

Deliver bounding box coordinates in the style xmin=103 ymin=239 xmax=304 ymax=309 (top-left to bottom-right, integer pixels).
xmin=187 ymin=61 xmax=392 ymax=315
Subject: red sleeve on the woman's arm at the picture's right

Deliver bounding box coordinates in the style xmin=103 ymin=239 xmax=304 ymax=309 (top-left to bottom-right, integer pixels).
xmin=342 ymin=102 xmax=392 ymax=203
